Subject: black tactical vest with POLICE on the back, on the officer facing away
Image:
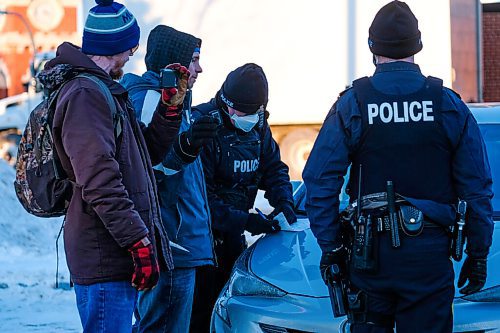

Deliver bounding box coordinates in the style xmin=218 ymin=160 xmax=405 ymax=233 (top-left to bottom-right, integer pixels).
xmin=348 ymin=77 xmax=456 ymax=203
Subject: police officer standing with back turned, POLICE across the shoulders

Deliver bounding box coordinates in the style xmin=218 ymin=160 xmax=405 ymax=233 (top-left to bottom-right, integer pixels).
xmin=303 ymin=1 xmax=493 ymax=333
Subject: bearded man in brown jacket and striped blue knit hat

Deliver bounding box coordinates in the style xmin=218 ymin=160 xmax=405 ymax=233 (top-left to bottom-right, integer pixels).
xmin=40 ymin=0 xmax=189 ymax=333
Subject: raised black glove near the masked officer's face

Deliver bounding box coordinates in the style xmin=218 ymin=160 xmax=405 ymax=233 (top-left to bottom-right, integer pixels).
xmin=174 ymin=116 xmax=218 ymax=163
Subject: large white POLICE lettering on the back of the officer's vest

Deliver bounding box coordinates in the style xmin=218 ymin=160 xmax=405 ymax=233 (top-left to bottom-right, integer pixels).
xmin=367 ymin=101 xmax=434 ymax=125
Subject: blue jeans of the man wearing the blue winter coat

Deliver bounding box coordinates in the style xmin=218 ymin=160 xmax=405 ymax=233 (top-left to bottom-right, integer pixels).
xmin=134 ymin=268 xmax=195 ymax=333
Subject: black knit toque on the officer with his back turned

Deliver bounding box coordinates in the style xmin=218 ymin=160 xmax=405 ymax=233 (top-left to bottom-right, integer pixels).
xmin=368 ymin=1 xmax=422 ymax=59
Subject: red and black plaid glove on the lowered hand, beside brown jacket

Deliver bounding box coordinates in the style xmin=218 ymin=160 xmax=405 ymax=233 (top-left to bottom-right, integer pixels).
xmin=128 ymin=237 xmax=160 ymax=290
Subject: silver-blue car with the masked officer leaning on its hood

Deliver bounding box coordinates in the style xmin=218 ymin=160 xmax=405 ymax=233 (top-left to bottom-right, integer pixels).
xmin=211 ymin=103 xmax=500 ymax=333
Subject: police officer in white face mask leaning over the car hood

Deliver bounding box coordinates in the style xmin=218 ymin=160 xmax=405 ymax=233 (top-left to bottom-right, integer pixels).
xmin=191 ymin=63 xmax=296 ymax=332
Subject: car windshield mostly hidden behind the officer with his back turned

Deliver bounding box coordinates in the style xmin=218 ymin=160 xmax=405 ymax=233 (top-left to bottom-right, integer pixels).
xmin=294 ymin=124 xmax=500 ymax=218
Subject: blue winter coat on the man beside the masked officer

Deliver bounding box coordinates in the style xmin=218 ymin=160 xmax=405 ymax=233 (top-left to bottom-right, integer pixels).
xmin=121 ymin=71 xmax=214 ymax=267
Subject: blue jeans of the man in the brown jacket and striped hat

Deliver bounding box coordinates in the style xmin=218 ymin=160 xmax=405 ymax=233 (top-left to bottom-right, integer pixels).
xmin=75 ymin=281 xmax=137 ymax=333
